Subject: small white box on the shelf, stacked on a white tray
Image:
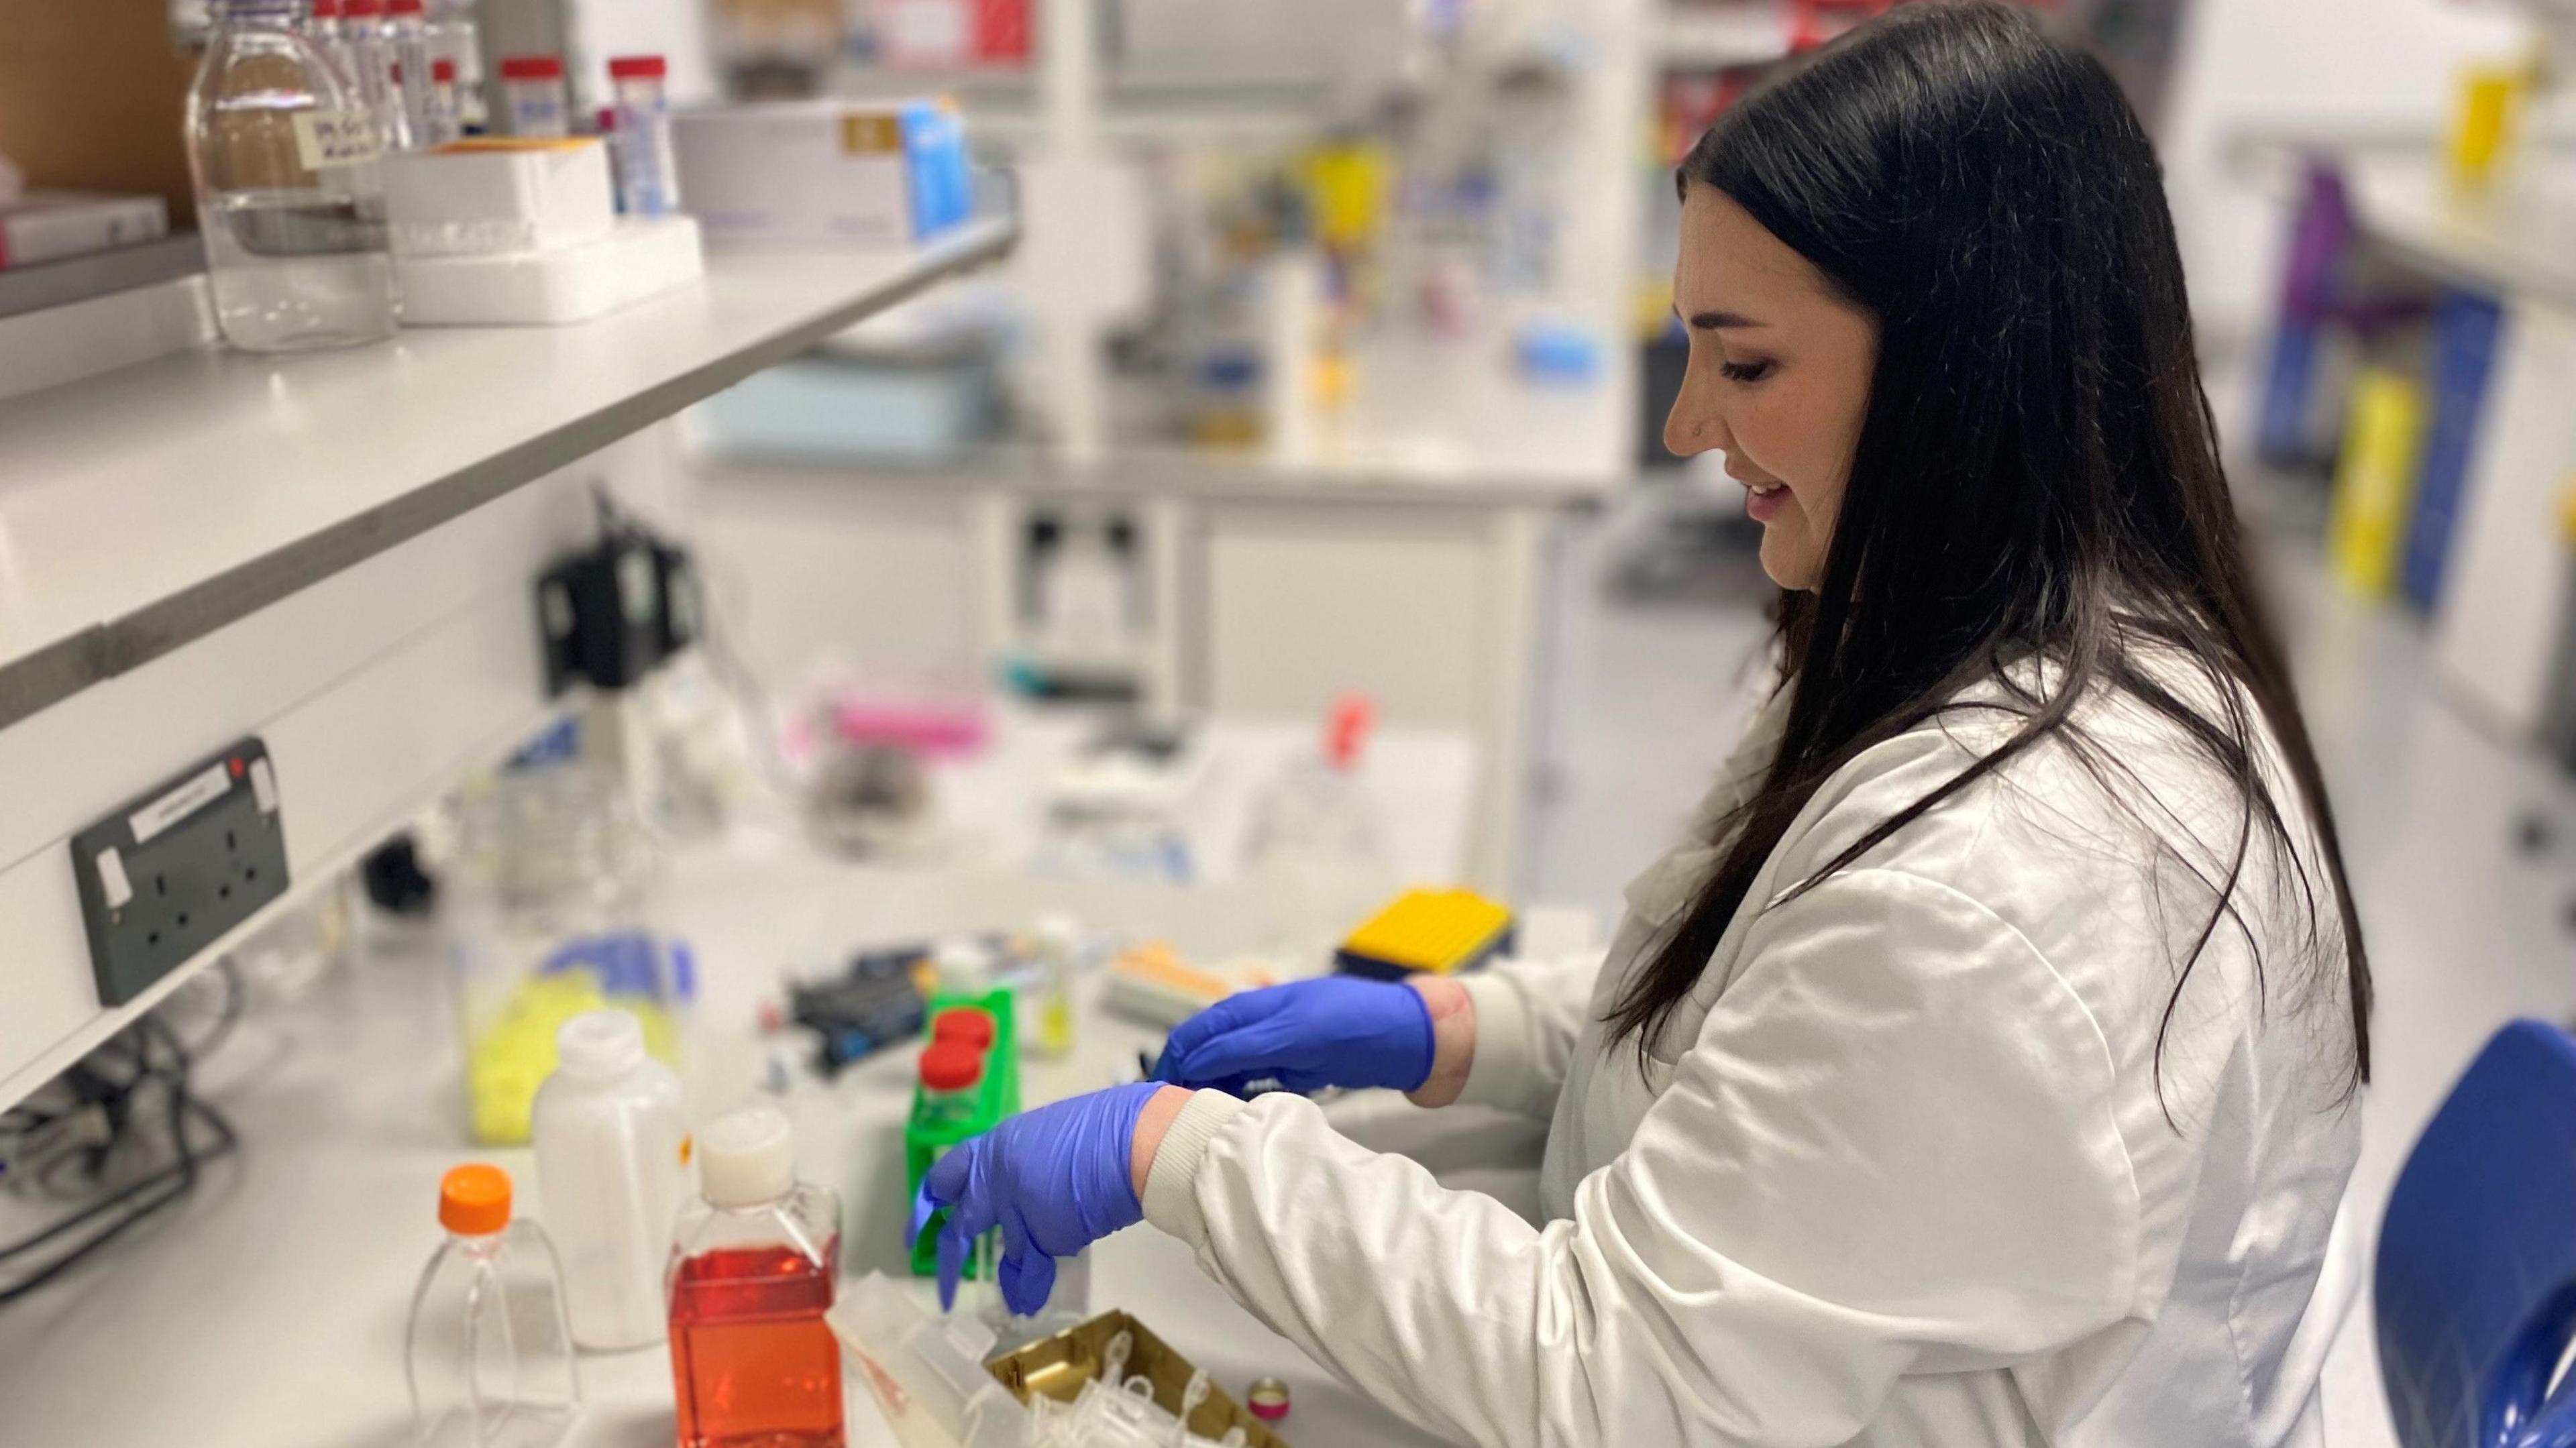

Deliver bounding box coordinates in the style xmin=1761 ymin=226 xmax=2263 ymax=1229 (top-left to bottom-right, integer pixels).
xmin=384 ymin=137 xmax=619 ymax=258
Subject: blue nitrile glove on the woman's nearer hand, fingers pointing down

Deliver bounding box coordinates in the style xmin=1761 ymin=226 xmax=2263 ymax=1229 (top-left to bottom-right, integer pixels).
xmin=912 ymin=1082 xmax=1162 ymax=1317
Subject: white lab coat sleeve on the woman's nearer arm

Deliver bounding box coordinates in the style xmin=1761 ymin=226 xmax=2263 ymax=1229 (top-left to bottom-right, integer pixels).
xmin=1144 ymin=871 xmax=2138 ymax=1448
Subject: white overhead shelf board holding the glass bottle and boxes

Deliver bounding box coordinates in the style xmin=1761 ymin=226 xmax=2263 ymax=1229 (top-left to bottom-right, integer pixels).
xmin=0 ymin=219 xmax=1018 ymax=729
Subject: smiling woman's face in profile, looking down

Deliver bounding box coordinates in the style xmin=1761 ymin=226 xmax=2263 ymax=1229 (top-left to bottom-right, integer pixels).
xmin=1664 ymin=183 xmax=1878 ymax=588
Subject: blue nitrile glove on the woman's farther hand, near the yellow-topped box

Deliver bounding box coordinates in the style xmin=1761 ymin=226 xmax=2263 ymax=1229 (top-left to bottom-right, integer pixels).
xmin=1154 ymin=977 xmax=1432 ymax=1095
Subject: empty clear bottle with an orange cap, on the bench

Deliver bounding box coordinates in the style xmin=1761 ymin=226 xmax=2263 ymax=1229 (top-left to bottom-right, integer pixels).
xmin=405 ymin=1164 xmax=582 ymax=1448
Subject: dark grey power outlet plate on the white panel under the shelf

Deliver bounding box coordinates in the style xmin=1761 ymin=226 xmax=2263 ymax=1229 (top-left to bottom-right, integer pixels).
xmin=72 ymin=740 xmax=286 ymax=1005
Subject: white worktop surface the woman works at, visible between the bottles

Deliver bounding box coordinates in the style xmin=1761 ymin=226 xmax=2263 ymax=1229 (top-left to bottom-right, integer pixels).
xmin=0 ymin=842 xmax=1450 ymax=1448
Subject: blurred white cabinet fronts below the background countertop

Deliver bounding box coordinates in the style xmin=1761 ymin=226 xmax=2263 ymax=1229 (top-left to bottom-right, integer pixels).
xmin=690 ymin=456 xmax=1566 ymax=891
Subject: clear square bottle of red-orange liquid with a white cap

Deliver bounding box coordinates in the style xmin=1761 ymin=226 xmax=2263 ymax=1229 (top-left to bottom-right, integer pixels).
xmin=669 ymin=1105 xmax=843 ymax=1448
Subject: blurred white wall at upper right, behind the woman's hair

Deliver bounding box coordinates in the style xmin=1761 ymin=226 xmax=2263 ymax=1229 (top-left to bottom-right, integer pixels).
xmin=2159 ymin=0 xmax=2527 ymax=340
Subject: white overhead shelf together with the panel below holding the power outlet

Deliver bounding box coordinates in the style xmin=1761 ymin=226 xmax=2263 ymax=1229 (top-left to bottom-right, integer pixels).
xmin=0 ymin=219 xmax=1018 ymax=1103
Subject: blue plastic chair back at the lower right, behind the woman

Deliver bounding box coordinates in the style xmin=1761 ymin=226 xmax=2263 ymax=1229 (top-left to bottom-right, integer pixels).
xmin=2373 ymin=1020 xmax=2576 ymax=1448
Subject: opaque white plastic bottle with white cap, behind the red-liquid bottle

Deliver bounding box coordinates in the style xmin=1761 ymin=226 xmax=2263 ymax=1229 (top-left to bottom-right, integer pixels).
xmin=533 ymin=1007 xmax=685 ymax=1353
